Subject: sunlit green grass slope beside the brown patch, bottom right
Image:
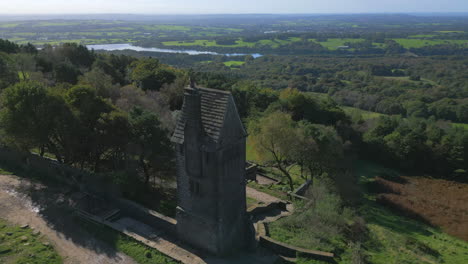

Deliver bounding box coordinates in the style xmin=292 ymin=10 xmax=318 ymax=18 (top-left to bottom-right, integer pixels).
xmin=355 ymin=160 xmax=468 ymax=264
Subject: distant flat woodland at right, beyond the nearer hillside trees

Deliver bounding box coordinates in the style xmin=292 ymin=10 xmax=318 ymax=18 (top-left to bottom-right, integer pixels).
xmin=196 ymin=56 xmax=468 ymax=123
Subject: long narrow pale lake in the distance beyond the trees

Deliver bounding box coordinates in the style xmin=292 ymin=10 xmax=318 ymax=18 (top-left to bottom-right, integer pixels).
xmin=86 ymin=43 xmax=262 ymax=58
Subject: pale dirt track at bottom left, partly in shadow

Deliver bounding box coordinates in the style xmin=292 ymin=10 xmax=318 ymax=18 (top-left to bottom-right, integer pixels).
xmin=0 ymin=175 xmax=135 ymax=264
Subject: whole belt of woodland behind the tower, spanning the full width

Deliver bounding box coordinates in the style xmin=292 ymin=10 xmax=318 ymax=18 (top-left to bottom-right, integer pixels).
xmin=0 ymin=38 xmax=468 ymax=196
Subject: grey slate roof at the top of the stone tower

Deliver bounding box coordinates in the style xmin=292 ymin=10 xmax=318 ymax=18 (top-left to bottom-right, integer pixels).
xmin=171 ymin=87 xmax=247 ymax=144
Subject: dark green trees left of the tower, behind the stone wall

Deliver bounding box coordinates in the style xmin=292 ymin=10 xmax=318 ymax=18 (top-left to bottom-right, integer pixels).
xmin=0 ymin=41 xmax=188 ymax=196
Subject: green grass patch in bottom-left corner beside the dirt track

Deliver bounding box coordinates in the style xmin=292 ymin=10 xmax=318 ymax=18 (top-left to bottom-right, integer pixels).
xmin=0 ymin=219 xmax=63 ymax=264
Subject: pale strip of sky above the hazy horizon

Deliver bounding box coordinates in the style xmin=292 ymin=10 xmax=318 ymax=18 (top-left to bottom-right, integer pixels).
xmin=0 ymin=0 xmax=468 ymax=14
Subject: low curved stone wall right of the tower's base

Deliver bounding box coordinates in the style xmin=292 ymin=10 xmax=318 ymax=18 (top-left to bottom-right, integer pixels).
xmin=260 ymin=235 xmax=335 ymax=263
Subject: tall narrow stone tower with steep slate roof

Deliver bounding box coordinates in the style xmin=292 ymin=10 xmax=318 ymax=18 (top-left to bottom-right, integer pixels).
xmin=171 ymin=83 xmax=251 ymax=255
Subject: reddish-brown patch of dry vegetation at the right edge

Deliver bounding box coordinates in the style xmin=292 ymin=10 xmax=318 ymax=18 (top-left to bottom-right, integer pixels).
xmin=376 ymin=177 xmax=468 ymax=241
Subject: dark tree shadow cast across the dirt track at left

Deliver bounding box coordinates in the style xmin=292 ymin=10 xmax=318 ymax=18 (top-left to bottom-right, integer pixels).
xmin=0 ymin=152 xmax=134 ymax=262
